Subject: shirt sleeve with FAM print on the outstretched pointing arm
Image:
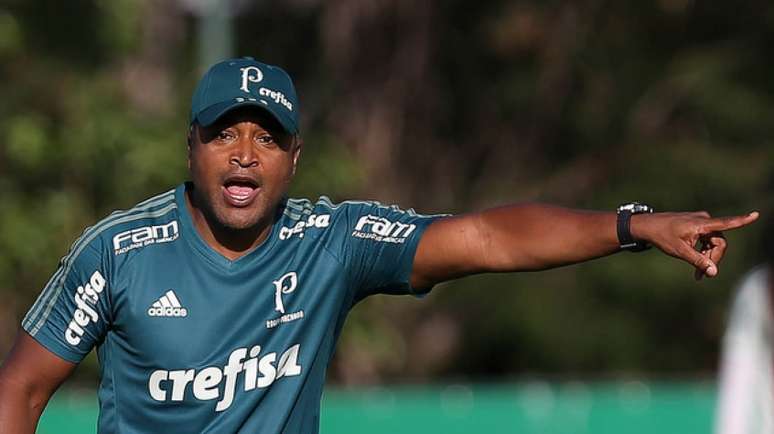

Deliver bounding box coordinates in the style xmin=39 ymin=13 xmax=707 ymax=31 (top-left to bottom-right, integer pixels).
xmin=328 ymin=202 xmax=444 ymax=302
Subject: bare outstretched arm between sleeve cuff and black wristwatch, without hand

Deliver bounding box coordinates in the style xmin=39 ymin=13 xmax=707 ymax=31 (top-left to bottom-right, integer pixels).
xmin=411 ymin=203 xmax=618 ymax=287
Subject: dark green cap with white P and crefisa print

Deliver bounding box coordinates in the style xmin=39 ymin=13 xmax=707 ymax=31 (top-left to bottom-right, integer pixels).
xmin=190 ymin=57 xmax=298 ymax=134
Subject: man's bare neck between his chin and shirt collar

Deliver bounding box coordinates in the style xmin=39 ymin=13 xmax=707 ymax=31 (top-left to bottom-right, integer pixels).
xmin=185 ymin=187 xmax=274 ymax=261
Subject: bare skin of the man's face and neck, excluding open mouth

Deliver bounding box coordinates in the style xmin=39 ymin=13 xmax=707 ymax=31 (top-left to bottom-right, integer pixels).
xmin=186 ymin=108 xmax=301 ymax=260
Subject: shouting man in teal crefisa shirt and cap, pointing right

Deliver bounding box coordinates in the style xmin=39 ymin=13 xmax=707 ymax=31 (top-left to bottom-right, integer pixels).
xmin=0 ymin=58 xmax=757 ymax=433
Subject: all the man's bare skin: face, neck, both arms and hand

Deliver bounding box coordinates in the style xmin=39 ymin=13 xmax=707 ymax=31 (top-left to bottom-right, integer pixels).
xmin=0 ymin=104 xmax=758 ymax=433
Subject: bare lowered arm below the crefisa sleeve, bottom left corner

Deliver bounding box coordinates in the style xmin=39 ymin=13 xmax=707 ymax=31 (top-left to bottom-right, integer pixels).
xmin=0 ymin=331 xmax=76 ymax=434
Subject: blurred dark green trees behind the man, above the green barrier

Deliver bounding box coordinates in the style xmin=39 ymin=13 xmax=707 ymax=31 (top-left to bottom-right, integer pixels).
xmin=0 ymin=0 xmax=774 ymax=432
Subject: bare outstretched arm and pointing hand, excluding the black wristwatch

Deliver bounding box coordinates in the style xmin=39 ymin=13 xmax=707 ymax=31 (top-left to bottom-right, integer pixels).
xmin=411 ymin=204 xmax=758 ymax=288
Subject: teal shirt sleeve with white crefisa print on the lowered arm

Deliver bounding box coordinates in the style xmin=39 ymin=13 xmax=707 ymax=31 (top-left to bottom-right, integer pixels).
xmin=22 ymin=232 xmax=110 ymax=363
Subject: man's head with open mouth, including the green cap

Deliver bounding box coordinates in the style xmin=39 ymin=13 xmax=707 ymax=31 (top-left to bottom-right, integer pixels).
xmin=188 ymin=58 xmax=301 ymax=234
